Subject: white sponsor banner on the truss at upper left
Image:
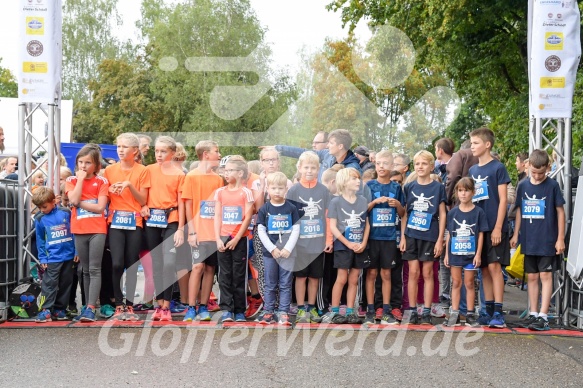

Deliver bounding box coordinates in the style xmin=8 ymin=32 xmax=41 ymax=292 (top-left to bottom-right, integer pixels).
xmin=17 ymin=0 xmax=63 ymax=104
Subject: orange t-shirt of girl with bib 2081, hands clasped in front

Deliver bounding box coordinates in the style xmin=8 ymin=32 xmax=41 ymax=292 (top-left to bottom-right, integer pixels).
xmin=103 ymin=162 xmax=151 ymax=227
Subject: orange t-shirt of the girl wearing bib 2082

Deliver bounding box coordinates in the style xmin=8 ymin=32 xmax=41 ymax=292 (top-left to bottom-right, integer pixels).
xmin=146 ymin=163 xmax=184 ymax=223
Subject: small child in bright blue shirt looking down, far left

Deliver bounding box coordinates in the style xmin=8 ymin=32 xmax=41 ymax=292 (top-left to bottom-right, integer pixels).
xmin=32 ymin=186 xmax=75 ymax=323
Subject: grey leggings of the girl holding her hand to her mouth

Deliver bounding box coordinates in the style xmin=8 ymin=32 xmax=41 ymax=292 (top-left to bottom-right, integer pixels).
xmin=75 ymin=234 xmax=105 ymax=307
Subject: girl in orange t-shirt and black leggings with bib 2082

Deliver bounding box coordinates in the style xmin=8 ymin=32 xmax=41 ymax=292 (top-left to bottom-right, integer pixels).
xmin=142 ymin=136 xmax=184 ymax=321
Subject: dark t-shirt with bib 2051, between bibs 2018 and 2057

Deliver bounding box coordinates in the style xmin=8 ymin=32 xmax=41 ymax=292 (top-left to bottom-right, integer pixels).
xmin=328 ymin=195 xmax=368 ymax=251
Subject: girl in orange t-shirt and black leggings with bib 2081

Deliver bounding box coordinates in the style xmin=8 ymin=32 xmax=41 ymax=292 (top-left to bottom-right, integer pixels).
xmin=104 ymin=133 xmax=150 ymax=321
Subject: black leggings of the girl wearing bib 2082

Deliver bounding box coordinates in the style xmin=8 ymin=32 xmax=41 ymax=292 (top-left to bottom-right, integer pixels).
xmin=144 ymin=222 xmax=178 ymax=301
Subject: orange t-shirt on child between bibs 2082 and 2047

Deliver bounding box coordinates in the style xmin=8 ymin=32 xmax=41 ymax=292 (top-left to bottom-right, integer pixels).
xmin=182 ymin=168 xmax=224 ymax=241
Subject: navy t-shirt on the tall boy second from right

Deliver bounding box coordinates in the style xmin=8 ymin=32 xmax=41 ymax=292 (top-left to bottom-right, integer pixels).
xmin=469 ymin=159 xmax=510 ymax=233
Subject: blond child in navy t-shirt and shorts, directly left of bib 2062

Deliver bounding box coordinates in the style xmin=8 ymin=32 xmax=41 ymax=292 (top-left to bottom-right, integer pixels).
xmin=400 ymin=151 xmax=446 ymax=325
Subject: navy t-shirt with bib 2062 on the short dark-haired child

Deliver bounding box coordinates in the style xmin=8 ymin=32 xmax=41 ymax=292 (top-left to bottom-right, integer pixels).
xmin=447 ymin=206 xmax=488 ymax=267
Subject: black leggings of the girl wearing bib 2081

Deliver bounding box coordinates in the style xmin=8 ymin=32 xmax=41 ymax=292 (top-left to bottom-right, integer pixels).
xmin=109 ymin=227 xmax=142 ymax=306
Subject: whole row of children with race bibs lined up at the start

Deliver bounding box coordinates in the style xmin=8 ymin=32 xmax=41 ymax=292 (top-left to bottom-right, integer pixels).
xmin=27 ymin=128 xmax=565 ymax=330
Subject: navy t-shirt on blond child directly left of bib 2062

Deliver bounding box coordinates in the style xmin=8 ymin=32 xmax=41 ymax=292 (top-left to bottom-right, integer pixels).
xmin=403 ymin=181 xmax=446 ymax=242
